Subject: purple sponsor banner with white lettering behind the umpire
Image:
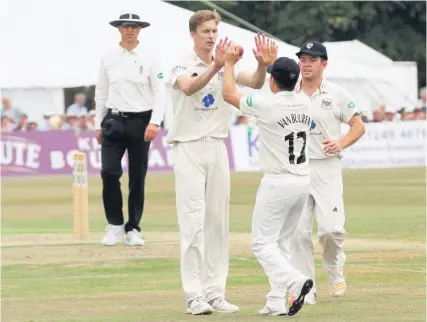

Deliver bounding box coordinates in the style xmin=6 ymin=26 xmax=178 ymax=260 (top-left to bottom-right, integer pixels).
xmin=0 ymin=130 xmax=234 ymax=176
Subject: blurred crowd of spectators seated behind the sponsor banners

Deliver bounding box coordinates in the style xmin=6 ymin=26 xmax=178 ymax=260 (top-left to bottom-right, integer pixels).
xmin=1 ymin=87 xmax=427 ymax=132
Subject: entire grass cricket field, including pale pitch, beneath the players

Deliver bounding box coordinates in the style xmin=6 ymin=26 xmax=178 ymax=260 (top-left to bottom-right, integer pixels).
xmin=2 ymin=168 xmax=426 ymax=322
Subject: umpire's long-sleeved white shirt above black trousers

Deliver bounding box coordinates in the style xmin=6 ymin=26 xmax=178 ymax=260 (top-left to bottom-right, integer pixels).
xmin=95 ymin=45 xmax=166 ymax=129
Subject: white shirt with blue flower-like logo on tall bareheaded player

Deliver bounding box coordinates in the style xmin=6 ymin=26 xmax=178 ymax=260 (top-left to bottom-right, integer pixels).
xmin=167 ymin=50 xmax=238 ymax=143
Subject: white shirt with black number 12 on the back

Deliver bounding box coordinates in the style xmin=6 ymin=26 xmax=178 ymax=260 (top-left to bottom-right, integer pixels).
xmin=240 ymin=91 xmax=311 ymax=175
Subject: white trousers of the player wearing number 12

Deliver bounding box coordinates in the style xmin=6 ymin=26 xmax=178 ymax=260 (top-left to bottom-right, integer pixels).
xmin=252 ymin=174 xmax=310 ymax=309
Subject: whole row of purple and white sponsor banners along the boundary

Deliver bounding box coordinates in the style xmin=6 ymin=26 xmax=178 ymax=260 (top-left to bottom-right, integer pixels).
xmin=0 ymin=121 xmax=426 ymax=176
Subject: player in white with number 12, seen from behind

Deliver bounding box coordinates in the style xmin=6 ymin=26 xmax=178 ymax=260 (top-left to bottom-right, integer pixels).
xmin=222 ymin=46 xmax=313 ymax=315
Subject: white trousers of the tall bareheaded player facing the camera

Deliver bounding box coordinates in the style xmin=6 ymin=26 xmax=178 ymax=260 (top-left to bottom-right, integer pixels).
xmin=174 ymin=138 xmax=230 ymax=302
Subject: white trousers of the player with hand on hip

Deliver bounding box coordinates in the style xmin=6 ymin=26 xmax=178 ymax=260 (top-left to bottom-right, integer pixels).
xmin=291 ymin=158 xmax=346 ymax=288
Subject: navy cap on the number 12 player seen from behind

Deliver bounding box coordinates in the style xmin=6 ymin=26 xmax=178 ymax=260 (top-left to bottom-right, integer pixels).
xmin=267 ymin=57 xmax=300 ymax=86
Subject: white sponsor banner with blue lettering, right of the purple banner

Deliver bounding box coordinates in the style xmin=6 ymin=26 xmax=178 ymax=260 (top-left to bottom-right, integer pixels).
xmin=230 ymin=121 xmax=426 ymax=171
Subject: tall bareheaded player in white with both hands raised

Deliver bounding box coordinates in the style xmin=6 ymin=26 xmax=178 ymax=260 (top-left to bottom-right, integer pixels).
xmin=167 ymin=10 xmax=278 ymax=315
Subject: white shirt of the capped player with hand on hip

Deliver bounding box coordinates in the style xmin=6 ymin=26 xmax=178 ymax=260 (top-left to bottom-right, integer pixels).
xmin=296 ymin=80 xmax=359 ymax=159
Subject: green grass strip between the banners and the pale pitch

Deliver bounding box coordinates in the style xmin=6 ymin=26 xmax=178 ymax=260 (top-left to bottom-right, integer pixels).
xmin=2 ymin=168 xmax=426 ymax=241
